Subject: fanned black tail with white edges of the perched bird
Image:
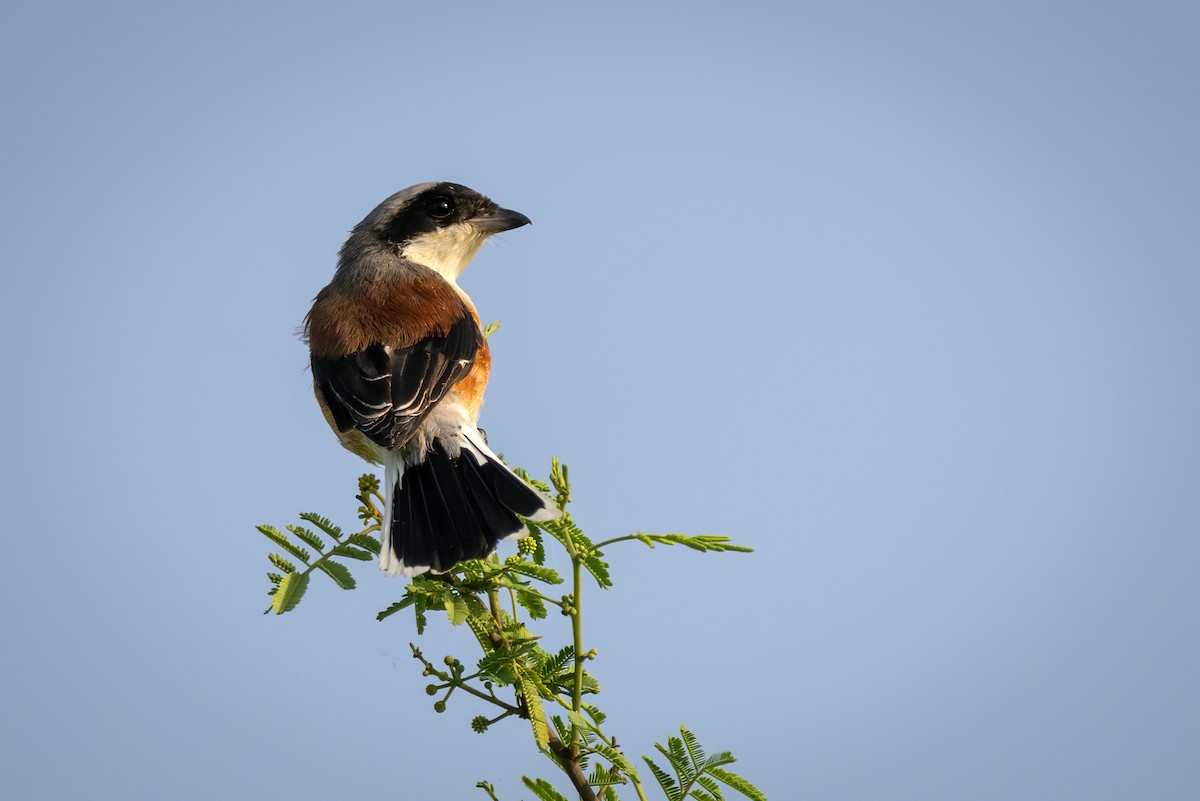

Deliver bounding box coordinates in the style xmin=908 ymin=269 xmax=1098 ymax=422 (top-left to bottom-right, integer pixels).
xmin=379 ymin=429 xmax=559 ymax=576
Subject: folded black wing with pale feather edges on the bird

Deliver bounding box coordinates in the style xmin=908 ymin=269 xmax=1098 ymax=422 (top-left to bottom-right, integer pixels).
xmin=312 ymin=315 xmax=481 ymax=450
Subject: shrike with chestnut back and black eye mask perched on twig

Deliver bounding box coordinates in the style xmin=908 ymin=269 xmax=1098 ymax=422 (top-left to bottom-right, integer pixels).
xmin=304 ymin=181 xmax=562 ymax=578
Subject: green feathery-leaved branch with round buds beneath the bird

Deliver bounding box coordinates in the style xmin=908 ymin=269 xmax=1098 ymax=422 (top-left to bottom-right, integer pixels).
xmin=258 ymin=459 xmax=764 ymax=801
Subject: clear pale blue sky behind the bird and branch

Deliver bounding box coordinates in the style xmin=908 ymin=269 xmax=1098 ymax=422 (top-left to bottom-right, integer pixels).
xmin=0 ymin=0 xmax=1200 ymax=801
